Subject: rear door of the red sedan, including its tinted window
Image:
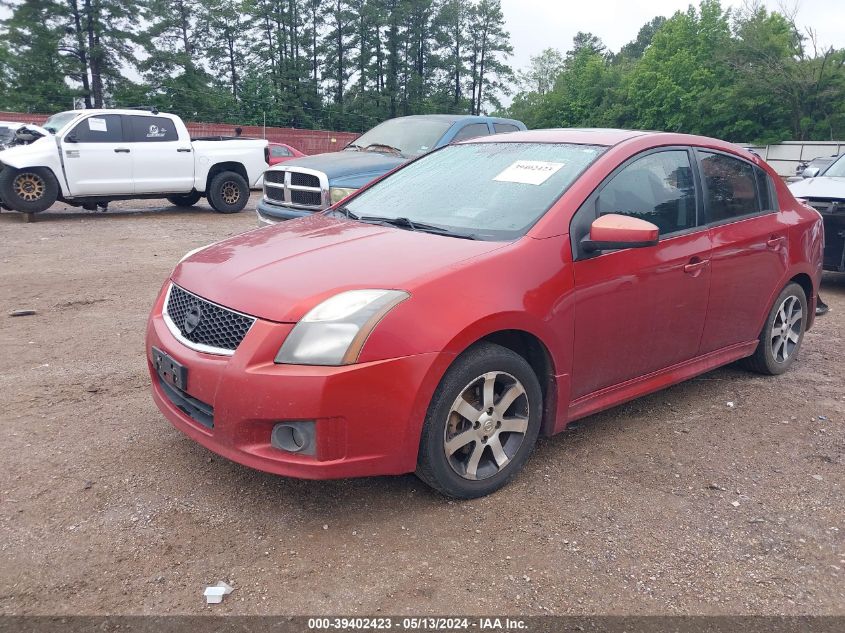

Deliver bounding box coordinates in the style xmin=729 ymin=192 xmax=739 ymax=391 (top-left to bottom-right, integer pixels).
xmin=696 ymin=150 xmax=789 ymax=354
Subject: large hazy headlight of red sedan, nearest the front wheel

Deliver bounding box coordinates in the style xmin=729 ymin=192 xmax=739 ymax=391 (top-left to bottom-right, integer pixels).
xmin=276 ymin=290 xmax=411 ymax=365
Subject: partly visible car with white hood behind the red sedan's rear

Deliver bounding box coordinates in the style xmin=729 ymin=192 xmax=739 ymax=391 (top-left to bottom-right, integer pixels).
xmin=789 ymin=154 xmax=845 ymax=273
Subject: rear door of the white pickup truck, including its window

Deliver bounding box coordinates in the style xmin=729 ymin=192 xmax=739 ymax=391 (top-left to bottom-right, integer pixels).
xmin=126 ymin=115 xmax=194 ymax=194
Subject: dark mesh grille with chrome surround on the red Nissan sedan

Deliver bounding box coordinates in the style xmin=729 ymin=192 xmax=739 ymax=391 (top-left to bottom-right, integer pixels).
xmin=165 ymin=284 xmax=255 ymax=355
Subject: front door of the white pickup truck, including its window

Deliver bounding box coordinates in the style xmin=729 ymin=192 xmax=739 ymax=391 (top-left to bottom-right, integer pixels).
xmin=61 ymin=114 xmax=135 ymax=197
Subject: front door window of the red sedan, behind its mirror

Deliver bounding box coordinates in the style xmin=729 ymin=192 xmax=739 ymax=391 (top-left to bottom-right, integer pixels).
xmin=596 ymin=150 xmax=697 ymax=236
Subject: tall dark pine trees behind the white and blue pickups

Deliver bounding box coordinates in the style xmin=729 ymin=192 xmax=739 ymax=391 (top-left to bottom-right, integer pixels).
xmin=0 ymin=0 xmax=514 ymax=131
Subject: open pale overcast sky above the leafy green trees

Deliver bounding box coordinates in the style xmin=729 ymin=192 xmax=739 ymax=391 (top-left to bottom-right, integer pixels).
xmin=502 ymin=0 xmax=845 ymax=69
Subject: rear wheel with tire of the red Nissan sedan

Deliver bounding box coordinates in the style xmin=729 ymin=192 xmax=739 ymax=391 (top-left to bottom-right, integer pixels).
xmin=741 ymin=283 xmax=808 ymax=376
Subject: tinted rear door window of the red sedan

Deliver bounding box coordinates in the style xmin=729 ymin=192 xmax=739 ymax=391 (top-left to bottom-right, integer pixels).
xmin=700 ymin=152 xmax=768 ymax=222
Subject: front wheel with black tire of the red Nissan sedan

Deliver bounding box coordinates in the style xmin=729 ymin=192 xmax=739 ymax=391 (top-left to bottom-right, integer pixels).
xmin=416 ymin=343 xmax=543 ymax=499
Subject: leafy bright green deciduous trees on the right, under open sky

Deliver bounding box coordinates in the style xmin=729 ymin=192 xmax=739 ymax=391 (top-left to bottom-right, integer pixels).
xmin=507 ymin=0 xmax=845 ymax=144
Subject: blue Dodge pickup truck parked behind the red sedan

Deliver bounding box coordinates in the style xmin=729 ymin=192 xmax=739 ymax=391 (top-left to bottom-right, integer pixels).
xmin=258 ymin=114 xmax=526 ymax=224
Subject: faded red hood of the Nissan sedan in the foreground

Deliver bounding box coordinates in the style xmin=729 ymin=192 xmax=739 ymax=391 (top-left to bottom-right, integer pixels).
xmin=172 ymin=214 xmax=505 ymax=323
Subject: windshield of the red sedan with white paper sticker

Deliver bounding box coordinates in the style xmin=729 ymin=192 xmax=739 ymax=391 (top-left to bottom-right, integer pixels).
xmin=341 ymin=143 xmax=606 ymax=240
